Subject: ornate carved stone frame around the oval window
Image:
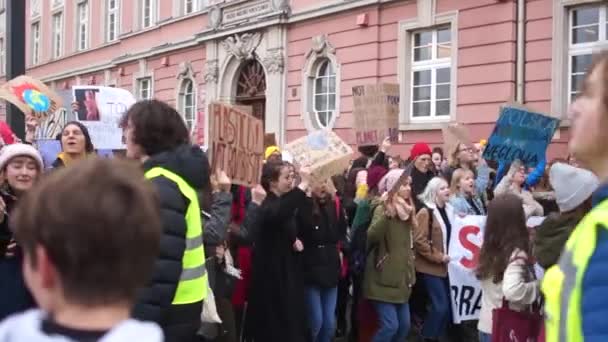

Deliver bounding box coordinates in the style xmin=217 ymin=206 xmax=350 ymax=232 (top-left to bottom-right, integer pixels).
xmin=300 ymin=35 xmax=341 ymax=132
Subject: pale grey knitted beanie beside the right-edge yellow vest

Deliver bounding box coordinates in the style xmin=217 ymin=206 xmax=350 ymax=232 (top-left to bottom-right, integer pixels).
xmin=549 ymin=163 xmax=600 ymax=212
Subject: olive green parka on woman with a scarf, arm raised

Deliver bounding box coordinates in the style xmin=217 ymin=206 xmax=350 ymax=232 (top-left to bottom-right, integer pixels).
xmin=363 ymin=201 xmax=416 ymax=304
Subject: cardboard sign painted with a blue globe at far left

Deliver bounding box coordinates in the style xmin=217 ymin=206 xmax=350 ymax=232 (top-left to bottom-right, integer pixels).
xmin=0 ymin=75 xmax=63 ymax=119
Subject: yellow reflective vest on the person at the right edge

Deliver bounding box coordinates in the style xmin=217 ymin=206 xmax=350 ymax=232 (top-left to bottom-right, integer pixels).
xmin=542 ymin=200 xmax=608 ymax=342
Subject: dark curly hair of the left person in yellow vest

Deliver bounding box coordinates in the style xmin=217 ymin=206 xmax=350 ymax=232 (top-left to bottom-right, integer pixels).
xmin=120 ymin=100 xmax=190 ymax=156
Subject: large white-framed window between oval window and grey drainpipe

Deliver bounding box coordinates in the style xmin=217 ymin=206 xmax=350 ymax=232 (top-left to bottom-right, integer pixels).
xmin=410 ymin=26 xmax=452 ymax=120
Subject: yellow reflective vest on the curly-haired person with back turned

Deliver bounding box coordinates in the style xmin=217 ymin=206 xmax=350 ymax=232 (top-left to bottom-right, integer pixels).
xmin=145 ymin=167 xmax=208 ymax=304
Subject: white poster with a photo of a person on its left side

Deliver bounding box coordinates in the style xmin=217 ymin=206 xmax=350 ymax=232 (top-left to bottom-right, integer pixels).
xmin=72 ymin=86 xmax=136 ymax=150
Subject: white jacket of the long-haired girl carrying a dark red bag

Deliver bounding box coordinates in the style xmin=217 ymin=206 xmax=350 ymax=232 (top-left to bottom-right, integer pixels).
xmin=477 ymin=249 xmax=540 ymax=334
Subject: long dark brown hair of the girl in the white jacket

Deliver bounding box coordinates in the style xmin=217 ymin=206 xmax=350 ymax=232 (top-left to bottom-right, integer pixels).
xmin=477 ymin=194 xmax=530 ymax=284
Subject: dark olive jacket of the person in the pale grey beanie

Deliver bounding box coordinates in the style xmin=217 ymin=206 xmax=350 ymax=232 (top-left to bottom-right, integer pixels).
xmin=534 ymin=212 xmax=584 ymax=269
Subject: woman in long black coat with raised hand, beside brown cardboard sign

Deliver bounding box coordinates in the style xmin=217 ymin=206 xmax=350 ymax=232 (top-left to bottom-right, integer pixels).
xmin=245 ymin=162 xmax=310 ymax=342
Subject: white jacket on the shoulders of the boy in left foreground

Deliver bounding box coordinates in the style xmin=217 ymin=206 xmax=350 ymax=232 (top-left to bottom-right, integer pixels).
xmin=0 ymin=310 xmax=164 ymax=342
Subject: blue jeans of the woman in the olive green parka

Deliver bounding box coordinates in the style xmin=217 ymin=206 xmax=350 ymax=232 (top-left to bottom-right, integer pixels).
xmin=372 ymin=301 xmax=410 ymax=342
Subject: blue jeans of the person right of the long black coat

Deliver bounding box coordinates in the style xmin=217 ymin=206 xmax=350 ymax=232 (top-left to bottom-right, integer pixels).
xmin=306 ymin=286 xmax=338 ymax=342
